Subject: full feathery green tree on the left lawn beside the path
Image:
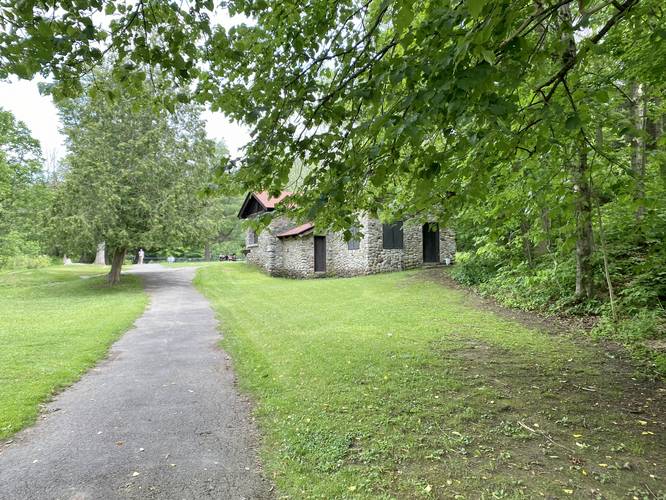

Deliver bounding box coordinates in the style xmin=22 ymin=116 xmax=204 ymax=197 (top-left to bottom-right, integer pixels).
xmin=53 ymin=75 xmax=215 ymax=282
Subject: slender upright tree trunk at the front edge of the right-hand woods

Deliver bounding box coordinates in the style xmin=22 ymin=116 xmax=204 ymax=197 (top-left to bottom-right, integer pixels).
xmin=574 ymin=137 xmax=594 ymax=299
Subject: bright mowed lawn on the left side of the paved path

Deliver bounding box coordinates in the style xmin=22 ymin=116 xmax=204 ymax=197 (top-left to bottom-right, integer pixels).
xmin=0 ymin=265 xmax=147 ymax=439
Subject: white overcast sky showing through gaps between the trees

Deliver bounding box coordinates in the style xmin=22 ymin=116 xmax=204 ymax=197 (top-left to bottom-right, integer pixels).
xmin=0 ymin=10 xmax=252 ymax=159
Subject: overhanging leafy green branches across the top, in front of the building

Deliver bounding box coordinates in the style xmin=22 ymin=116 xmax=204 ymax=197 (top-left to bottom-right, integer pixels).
xmin=0 ymin=0 xmax=666 ymax=227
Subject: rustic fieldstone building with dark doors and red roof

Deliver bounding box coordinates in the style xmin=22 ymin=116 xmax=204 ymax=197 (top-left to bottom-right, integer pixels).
xmin=238 ymin=192 xmax=456 ymax=278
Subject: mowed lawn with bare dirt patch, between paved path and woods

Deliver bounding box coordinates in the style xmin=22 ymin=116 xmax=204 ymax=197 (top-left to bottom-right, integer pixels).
xmin=196 ymin=265 xmax=666 ymax=499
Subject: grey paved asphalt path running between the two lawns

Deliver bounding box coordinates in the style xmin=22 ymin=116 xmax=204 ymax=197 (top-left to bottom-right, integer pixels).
xmin=0 ymin=264 xmax=271 ymax=500
